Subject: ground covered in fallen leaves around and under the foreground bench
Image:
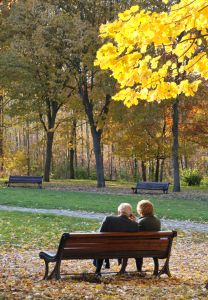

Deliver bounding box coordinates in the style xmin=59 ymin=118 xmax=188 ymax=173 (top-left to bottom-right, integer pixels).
xmin=0 ymin=234 xmax=208 ymax=300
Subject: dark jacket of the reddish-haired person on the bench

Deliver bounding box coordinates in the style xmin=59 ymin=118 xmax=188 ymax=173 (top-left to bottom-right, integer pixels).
xmin=138 ymin=215 xmax=161 ymax=231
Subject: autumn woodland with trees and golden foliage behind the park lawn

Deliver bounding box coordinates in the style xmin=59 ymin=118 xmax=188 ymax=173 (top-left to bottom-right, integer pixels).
xmin=0 ymin=0 xmax=208 ymax=187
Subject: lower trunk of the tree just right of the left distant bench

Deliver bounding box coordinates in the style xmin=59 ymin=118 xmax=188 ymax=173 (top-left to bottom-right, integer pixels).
xmin=44 ymin=131 xmax=54 ymax=182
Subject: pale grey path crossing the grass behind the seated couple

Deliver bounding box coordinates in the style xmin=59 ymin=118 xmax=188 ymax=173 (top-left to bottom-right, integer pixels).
xmin=0 ymin=205 xmax=208 ymax=233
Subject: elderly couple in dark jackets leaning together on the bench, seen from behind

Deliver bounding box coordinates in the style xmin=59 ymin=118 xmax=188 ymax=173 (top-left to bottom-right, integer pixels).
xmin=94 ymin=200 xmax=161 ymax=275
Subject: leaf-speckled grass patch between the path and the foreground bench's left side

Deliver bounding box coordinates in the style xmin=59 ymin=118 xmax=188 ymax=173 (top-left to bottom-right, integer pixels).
xmin=0 ymin=211 xmax=100 ymax=250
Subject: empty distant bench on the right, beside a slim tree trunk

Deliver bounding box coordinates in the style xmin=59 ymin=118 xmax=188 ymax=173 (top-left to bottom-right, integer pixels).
xmin=131 ymin=181 xmax=170 ymax=194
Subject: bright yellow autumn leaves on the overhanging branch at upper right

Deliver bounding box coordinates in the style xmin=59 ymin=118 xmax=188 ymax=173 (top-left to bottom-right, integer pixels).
xmin=95 ymin=0 xmax=208 ymax=106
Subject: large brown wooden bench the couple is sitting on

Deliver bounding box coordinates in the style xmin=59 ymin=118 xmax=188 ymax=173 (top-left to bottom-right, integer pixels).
xmin=39 ymin=231 xmax=177 ymax=279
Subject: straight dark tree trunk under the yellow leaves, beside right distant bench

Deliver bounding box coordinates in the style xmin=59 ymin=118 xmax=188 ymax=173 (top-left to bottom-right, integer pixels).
xmin=172 ymin=99 xmax=180 ymax=192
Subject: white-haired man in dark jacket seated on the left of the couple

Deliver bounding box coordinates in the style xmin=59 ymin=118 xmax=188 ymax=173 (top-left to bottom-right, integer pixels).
xmin=94 ymin=203 xmax=138 ymax=275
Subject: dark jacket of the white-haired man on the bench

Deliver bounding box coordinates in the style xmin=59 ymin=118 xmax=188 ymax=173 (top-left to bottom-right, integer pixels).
xmin=100 ymin=215 xmax=138 ymax=232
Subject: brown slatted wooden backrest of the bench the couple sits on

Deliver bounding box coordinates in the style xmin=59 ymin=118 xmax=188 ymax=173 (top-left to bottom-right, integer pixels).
xmin=54 ymin=231 xmax=177 ymax=259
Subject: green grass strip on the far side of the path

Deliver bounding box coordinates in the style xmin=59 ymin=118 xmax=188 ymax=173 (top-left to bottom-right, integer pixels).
xmin=0 ymin=188 xmax=208 ymax=222
